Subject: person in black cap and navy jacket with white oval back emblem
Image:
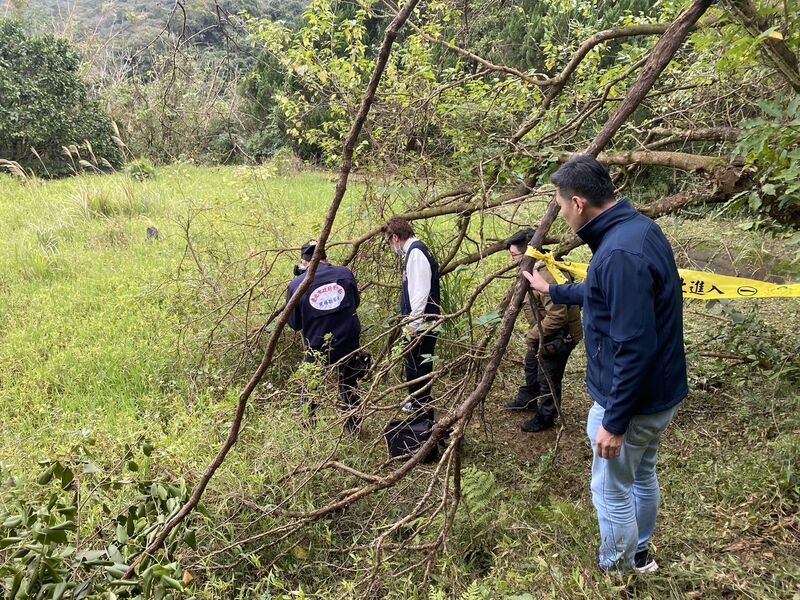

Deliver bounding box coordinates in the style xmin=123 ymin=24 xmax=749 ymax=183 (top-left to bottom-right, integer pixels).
xmin=287 ymin=242 xmax=361 ymax=432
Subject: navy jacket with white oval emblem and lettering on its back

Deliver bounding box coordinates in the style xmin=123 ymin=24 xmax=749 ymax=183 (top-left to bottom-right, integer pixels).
xmin=286 ymin=263 xmax=361 ymax=354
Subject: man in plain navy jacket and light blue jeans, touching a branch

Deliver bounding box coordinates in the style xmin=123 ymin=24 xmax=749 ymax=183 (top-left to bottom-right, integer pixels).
xmin=523 ymin=155 xmax=688 ymax=572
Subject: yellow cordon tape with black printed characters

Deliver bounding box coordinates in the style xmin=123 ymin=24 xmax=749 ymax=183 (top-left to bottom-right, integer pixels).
xmin=525 ymin=247 xmax=800 ymax=300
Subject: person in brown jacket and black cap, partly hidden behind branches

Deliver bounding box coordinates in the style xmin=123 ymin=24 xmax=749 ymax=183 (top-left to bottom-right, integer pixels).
xmin=506 ymin=229 xmax=583 ymax=433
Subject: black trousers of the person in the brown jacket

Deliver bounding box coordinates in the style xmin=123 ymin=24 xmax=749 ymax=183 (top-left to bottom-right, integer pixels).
xmin=517 ymin=341 xmax=578 ymax=423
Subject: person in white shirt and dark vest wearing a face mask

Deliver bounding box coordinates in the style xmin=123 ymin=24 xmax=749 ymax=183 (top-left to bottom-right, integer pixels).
xmin=383 ymin=217 xmax=442 ymax=421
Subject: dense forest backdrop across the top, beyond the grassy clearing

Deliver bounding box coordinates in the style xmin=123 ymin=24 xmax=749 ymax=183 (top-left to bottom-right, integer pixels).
xmin=0 ymin=0 xmax=800 ymax=225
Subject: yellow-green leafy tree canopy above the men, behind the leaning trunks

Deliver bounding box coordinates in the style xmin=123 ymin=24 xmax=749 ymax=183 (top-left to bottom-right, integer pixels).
xmin=247 ymin=0 xmax=800 ymax=222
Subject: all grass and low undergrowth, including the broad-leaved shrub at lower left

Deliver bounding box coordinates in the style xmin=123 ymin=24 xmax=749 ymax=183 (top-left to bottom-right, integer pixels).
xmin=0 ymin=165 xmax=800 ymax=600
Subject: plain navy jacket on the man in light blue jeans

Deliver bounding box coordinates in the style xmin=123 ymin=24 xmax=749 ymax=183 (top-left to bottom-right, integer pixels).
xmin=550 ymin=199 xmax=689 ymax=435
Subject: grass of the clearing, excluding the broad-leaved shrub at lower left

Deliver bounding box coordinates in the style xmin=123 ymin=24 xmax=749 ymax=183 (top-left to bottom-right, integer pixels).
xmin=0 ymin=166 xmax=800 ymax=599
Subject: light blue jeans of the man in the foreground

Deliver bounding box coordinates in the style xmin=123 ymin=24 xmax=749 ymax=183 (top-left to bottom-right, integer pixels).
xmin=586 ymin=402 xmax=680 ymax=571
